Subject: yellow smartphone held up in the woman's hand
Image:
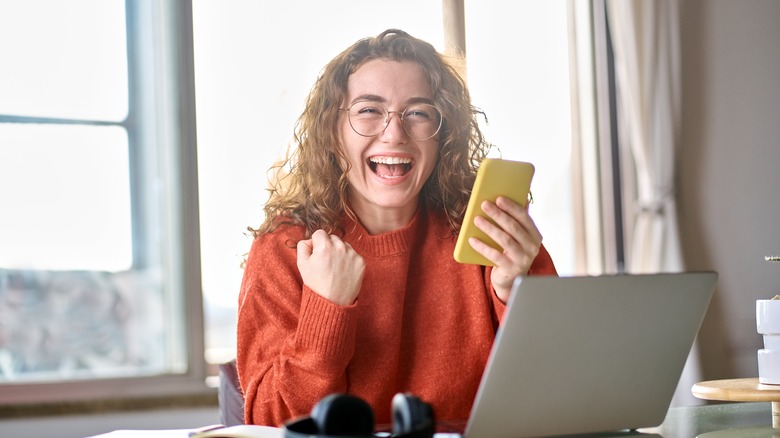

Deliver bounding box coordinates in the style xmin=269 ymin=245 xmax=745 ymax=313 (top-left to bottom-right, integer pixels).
xmin=453 ymin=158 xmax=534 ymax=266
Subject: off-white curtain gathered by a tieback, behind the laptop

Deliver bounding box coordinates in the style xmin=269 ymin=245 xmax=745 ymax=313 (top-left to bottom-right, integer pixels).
xmin=607 ymin=0 xmax=701 ymax=406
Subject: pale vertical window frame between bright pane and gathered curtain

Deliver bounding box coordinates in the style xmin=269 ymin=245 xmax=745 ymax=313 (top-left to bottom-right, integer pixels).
xmin=567 ymin=0 xmax=633 ymax=275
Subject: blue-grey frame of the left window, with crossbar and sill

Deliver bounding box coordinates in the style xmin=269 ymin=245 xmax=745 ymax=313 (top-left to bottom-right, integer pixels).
xmin=0 ymin=0 xmax=216 ymax=406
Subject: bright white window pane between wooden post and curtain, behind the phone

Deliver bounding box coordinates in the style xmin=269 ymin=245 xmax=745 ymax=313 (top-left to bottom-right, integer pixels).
xmin=465 ymin=0 xmax=576 ymax=275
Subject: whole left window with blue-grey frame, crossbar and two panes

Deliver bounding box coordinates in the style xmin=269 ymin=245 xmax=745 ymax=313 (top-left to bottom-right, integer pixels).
xmin=0 ymin=0 xmax=204 ymax=403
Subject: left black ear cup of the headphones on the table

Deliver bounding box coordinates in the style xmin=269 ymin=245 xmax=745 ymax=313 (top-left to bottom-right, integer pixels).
xmin=311 ymin=394 xmax=374 ymax=436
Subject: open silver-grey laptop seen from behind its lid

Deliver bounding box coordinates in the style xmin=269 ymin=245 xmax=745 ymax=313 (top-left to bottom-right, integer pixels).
xmin=464 ymin=272 xmax=717 ymax=438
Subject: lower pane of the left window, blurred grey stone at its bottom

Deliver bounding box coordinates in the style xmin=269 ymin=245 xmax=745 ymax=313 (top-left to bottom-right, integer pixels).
xmin=0 ymin=124 xmax=187 ymax=383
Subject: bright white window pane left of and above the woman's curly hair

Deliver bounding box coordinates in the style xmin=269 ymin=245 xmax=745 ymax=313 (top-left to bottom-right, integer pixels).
xmin=193 ymin=0 xmax=444 ymax=362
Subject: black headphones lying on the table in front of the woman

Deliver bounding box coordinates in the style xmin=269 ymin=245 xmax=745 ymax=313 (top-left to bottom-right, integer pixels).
xmin=284 ymin=394 xmax=436 ymax=438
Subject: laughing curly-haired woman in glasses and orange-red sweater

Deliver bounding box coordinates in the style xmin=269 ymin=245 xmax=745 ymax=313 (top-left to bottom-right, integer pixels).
xmin=237 ymin=30 xmax=555 ymax=425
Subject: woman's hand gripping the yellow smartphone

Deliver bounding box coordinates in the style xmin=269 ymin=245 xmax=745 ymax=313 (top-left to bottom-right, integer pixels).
xmin=469 ymin=196 xmax=542 ymax=303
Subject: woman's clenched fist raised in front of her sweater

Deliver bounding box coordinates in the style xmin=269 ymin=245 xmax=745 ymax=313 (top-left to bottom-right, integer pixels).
xmin=297 ymin=230 xmax=366 ymax=306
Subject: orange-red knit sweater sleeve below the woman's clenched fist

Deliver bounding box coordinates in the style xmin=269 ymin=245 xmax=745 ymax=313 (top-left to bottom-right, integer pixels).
xmin=236 ymin=229 xmax=358 ymax=426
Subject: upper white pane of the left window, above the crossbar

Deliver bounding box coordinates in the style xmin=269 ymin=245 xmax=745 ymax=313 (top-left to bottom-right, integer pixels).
xmin=0 ymin=0 xmax=128 ymax=121
